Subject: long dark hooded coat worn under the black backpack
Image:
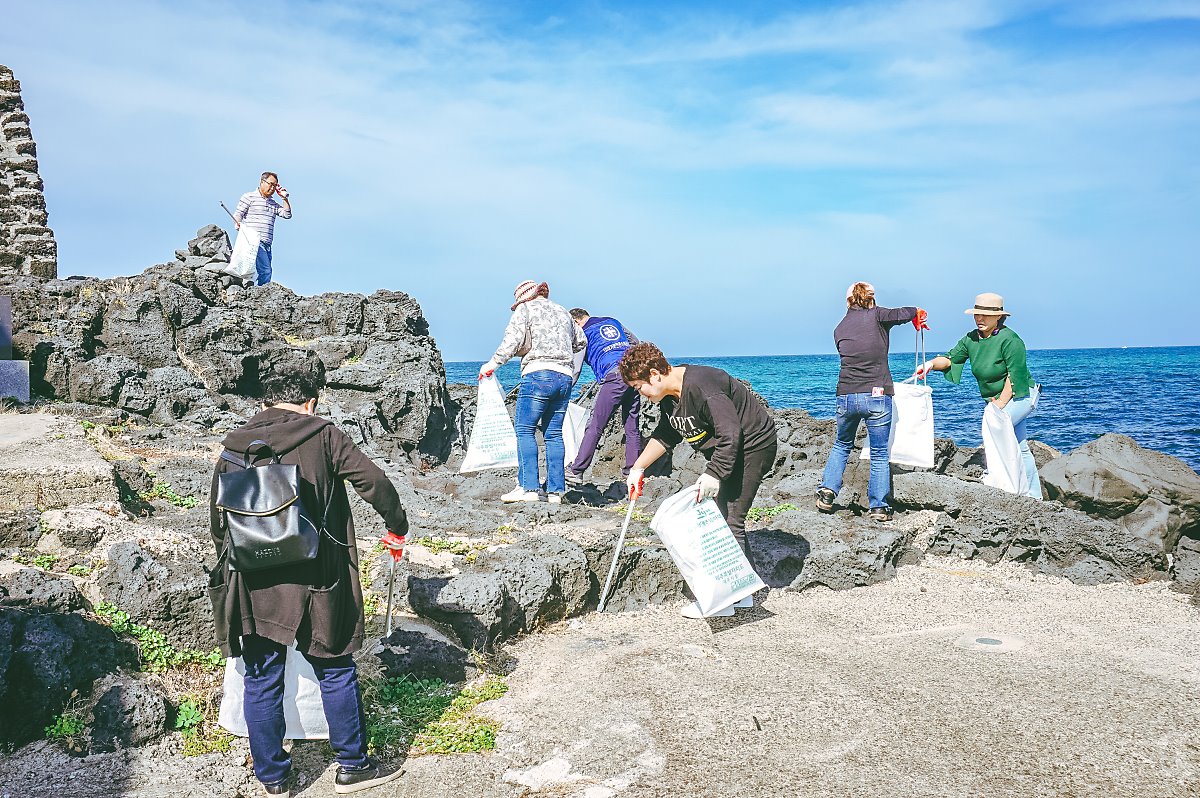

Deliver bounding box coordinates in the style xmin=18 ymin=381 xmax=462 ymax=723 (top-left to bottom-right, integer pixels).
xmin=209 ymin=408 xmax=408 ymax=658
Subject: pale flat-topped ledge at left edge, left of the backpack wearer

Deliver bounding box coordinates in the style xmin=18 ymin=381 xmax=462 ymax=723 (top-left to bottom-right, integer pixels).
xmin=0 ymin=413 xmax=118 ymax=511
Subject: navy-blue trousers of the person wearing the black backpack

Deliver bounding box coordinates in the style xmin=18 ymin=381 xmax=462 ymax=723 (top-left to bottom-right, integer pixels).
xmin=241 ymin=635 xmax=371 ymax=785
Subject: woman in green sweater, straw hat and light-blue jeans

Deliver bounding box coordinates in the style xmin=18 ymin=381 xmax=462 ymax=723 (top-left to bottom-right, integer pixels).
xmin=917 ymin=294 xmax=1042 ymax=499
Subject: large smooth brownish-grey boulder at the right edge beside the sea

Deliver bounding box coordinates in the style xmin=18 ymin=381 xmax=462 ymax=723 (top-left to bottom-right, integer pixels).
xmin=1042 ymin=433 xmax=1200 ymax=593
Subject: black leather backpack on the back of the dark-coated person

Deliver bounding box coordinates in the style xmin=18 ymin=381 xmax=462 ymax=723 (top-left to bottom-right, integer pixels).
xmin=216 ymin=440 xmax=333 ymax=571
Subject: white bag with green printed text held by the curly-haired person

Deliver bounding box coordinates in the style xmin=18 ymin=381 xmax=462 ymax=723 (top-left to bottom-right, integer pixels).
xmin=650 ymin=486 xmax=767 ymax=616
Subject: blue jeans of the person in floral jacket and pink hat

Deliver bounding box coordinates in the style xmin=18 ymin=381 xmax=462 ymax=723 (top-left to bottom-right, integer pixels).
xmin=514 ymin=371 xmax=571 ymax=493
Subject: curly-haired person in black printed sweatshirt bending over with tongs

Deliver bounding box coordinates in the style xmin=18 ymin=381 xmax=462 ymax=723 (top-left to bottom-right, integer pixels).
xmin=618 ymin=342 xmax=779 ymax=618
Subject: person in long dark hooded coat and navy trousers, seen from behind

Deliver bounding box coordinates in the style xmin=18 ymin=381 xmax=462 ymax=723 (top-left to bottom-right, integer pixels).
xmin=209 ymin=358 xmax=408 ymax=796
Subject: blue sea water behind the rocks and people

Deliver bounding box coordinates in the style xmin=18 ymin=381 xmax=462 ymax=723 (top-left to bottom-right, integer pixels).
xmin=446 ymin=347 xmax=1200 ymax=470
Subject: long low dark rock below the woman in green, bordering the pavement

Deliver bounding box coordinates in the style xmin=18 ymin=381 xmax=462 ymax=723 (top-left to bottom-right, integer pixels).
xmin=892 ymin=473 xmax=1166 ymax=584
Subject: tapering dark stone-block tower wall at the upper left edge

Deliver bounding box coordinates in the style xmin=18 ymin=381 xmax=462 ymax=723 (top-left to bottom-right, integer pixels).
xmin=0 ymin=65 xmax=58 ymax=277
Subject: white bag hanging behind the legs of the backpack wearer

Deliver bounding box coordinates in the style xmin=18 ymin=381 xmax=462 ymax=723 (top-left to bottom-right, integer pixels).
xmin=217 ymin=643 xmax=329 ymax=740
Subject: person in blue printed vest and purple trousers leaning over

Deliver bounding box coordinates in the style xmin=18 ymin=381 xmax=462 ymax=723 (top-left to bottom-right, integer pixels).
xmin=566 ymin=307 xmax=642 ymax=485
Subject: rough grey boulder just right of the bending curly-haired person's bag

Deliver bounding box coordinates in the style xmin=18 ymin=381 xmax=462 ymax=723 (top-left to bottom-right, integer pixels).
xmin=750 ymin=510 xmax=908 ymax=590
